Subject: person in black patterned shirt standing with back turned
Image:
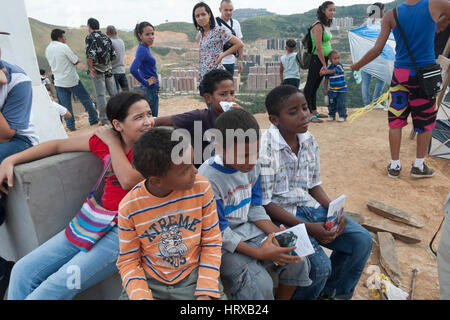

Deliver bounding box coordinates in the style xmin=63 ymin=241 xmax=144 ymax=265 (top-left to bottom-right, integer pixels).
xmin=85 ymin=18 xmax=117 ymax=124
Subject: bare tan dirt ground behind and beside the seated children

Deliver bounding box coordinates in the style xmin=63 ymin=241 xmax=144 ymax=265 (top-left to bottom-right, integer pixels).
xmin=68 ymin=96 xmax=450 ymax=300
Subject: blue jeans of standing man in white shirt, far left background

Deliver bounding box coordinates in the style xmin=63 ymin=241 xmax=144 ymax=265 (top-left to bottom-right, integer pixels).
xmin=55 ymin=81 xmax=98 ymax=130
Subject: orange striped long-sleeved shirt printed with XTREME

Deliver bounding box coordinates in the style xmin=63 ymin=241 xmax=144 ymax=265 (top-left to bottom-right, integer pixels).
xmin=117 ymin=176 xmax=222 ymax=300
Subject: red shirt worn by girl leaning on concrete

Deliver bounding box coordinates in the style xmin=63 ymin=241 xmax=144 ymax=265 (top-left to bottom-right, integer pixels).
xmin=89 ymin=135 xmax=133 ymax=211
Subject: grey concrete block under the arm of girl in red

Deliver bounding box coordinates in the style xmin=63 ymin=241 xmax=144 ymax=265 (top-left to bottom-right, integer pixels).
xmin=0 ymin=152 xmax=121 ymax=300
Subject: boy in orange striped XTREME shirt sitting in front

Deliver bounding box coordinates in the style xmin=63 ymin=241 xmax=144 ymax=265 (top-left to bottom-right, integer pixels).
xmin=117 ymin=127 xmax=224 ymax=300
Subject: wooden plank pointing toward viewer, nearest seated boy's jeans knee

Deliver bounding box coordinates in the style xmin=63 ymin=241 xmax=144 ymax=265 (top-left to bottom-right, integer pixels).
xmin=378 ymin=232 xmax=402 ymax=287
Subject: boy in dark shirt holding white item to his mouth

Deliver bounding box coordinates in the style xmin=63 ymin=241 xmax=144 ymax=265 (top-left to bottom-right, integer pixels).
xmin=155 ymin=69 xmax=240 ymax=168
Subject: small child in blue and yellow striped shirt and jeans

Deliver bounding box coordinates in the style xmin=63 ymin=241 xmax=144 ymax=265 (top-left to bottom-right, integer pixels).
xmin=323 ymin=50 xmax=347 ymax=122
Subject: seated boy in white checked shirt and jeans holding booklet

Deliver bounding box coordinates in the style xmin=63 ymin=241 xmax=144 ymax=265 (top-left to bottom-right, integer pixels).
xmin=260 ymin=85 xmax=372 ymax=300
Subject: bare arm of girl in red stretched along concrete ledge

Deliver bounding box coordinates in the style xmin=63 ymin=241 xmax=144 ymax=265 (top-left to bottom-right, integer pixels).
xmin=0 ymin=134 xmax=92 ymax=194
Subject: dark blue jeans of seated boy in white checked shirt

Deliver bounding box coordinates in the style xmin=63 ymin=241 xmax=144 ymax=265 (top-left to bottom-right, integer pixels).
xmin=293 ymin=206 xmax=372 ymax=300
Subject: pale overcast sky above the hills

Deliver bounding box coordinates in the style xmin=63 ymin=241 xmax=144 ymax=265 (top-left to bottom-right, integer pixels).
xmin=25 ymin=0 xmax=391 ymax=29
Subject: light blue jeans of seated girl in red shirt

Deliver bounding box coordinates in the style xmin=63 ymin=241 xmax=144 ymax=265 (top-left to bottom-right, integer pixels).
xmin=8 ymin=227 xmax=119 ymax=300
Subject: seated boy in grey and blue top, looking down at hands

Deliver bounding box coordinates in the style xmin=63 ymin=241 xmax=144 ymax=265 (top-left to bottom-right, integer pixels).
xmin=199 ymin=109 xmax=311 ymax=300
